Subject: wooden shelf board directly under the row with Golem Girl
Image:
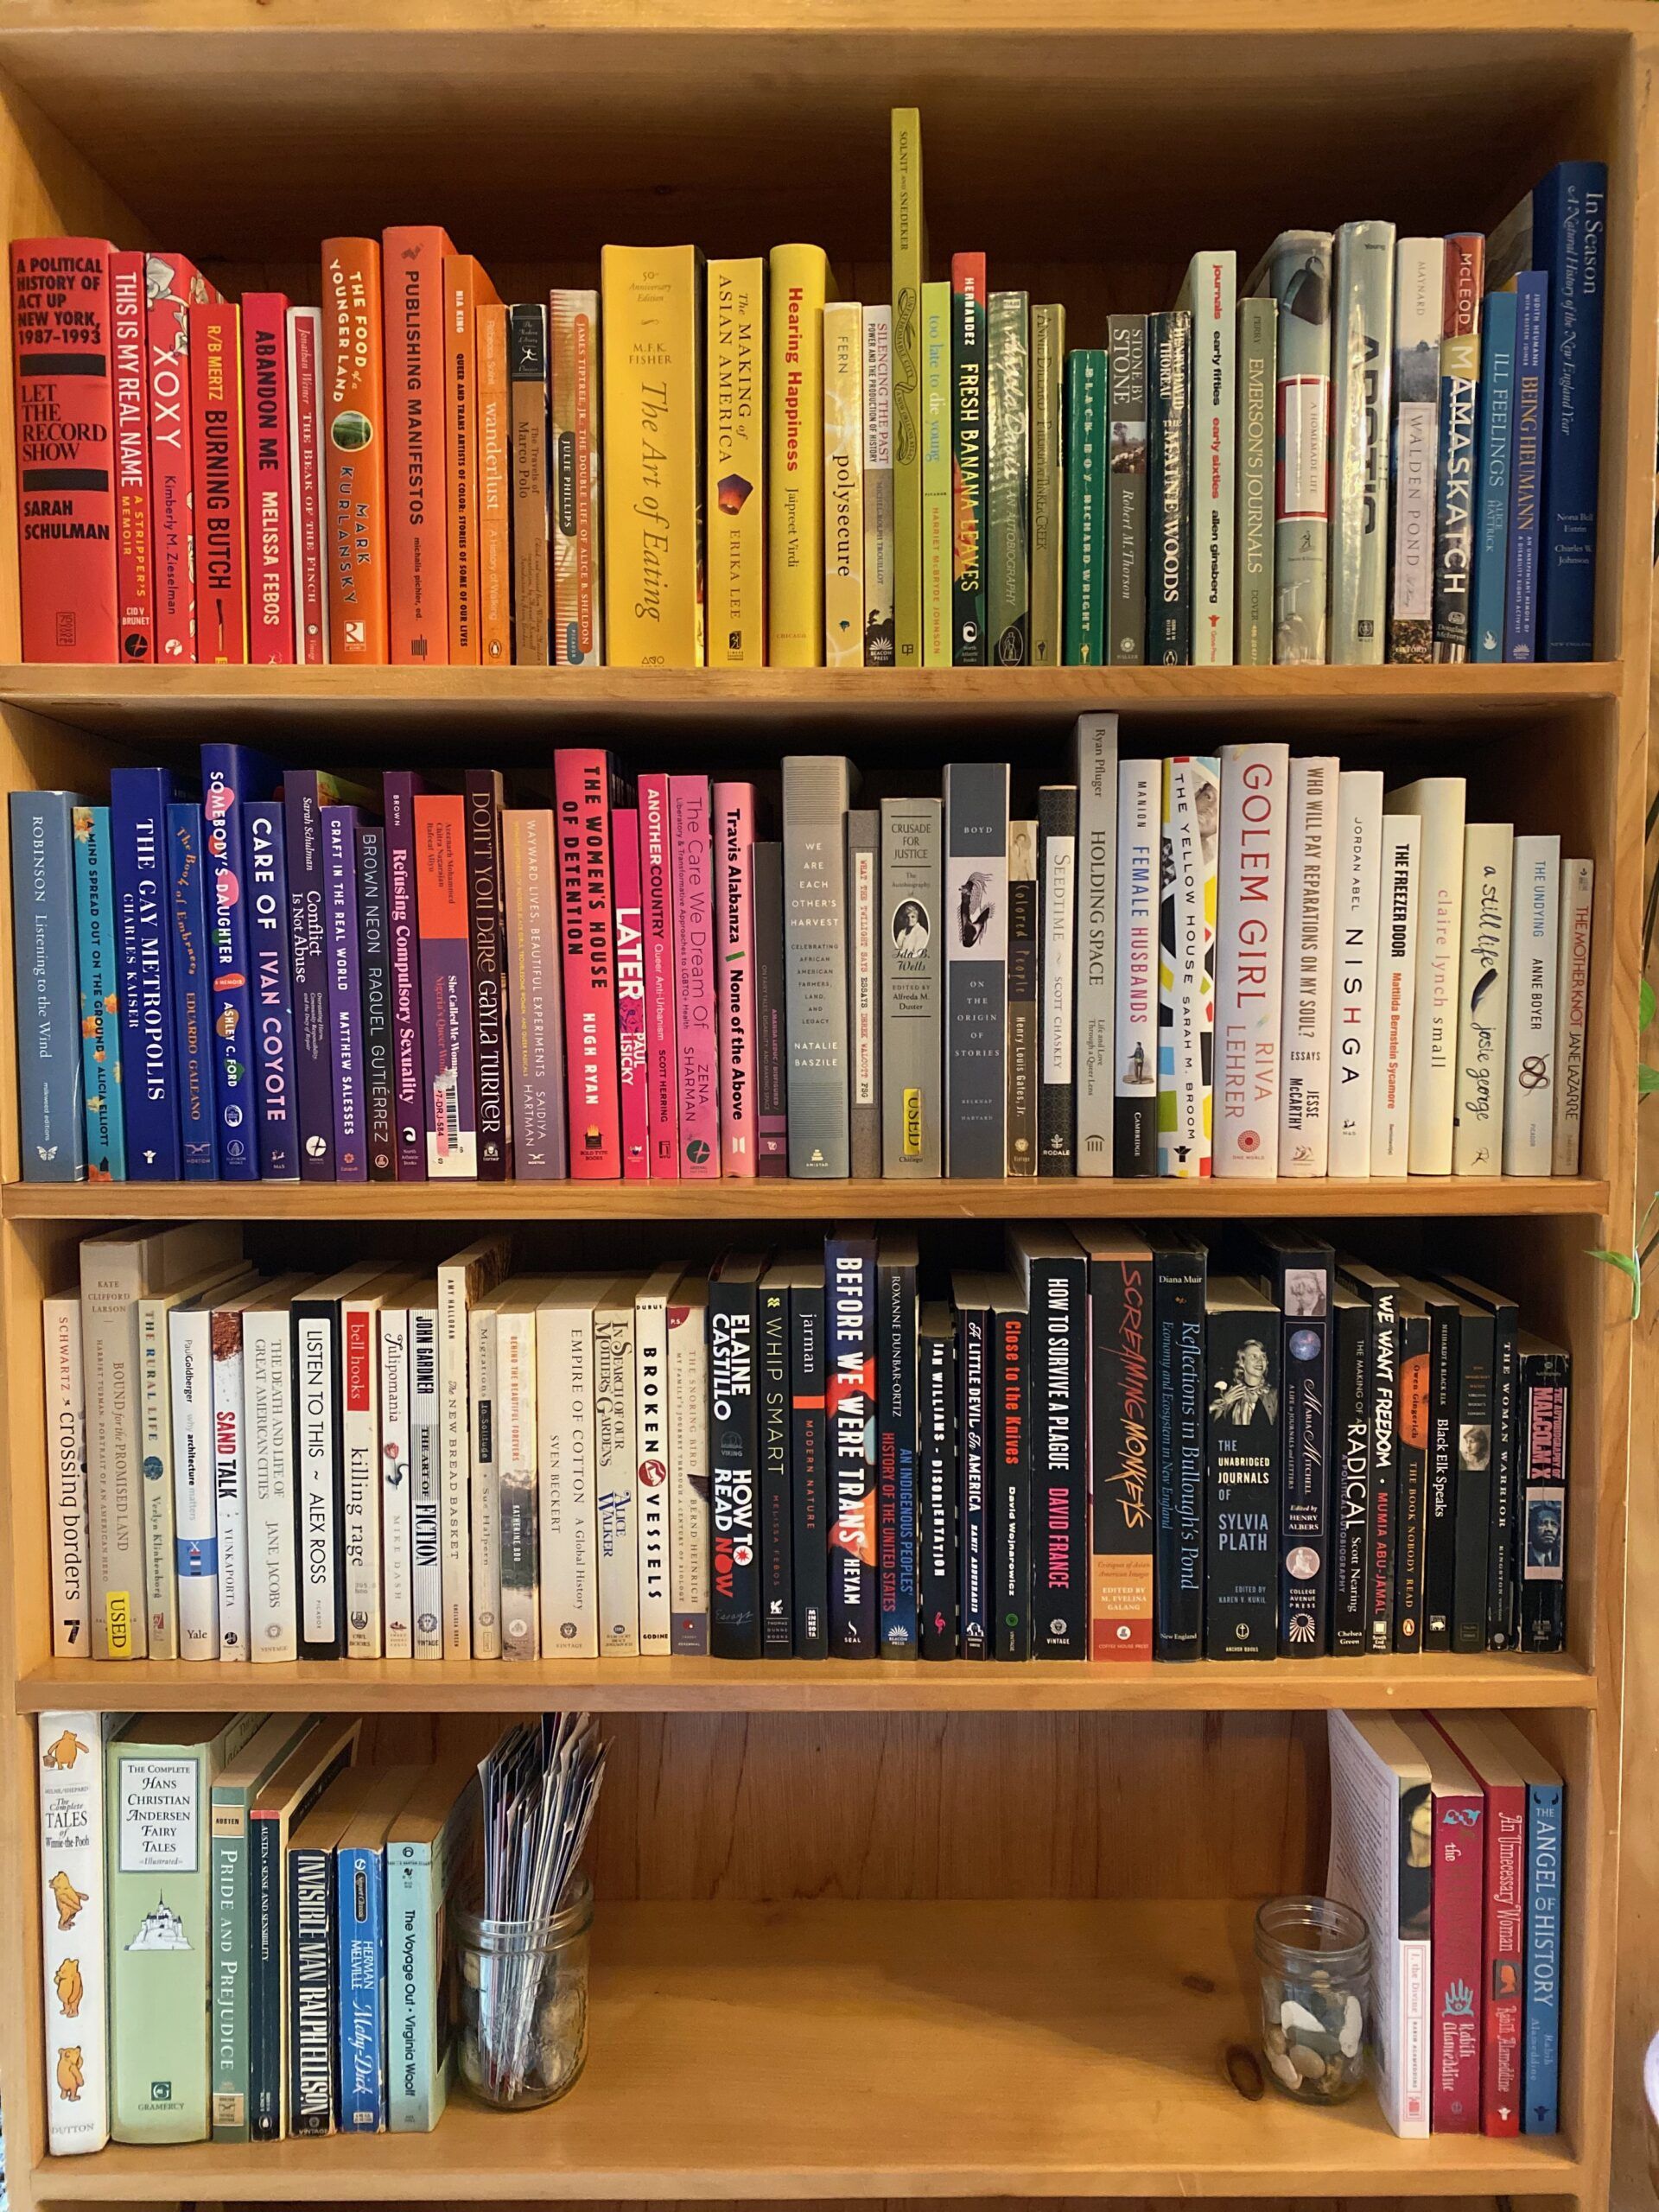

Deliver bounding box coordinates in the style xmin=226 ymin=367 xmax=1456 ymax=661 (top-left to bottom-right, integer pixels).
xmin=0 ymin=1174 xmax=1608 ymax=1221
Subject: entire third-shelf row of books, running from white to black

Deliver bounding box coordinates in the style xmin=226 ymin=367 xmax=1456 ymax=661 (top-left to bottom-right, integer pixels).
xmin=44 ymin=1225 xmax=1571 ymax=1663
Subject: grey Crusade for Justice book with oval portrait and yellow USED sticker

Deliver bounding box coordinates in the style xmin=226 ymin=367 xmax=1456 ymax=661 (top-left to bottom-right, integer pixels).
xmin=878 ymin=798 xmax=944 ymax=1179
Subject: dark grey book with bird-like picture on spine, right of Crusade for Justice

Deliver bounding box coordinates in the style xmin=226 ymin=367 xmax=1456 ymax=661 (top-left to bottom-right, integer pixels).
xmin=946 ymin=761 xmax=1008 ymax=1174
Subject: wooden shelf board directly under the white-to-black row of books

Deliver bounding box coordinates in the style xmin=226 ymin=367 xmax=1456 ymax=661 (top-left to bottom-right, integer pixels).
xmin=16 ymin=1652 xmax=1595 ymax=1712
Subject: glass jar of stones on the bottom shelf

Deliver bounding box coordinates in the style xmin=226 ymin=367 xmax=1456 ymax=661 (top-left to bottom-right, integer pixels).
xmin=1256 ymin=1897 xmax=1371 ymax=2104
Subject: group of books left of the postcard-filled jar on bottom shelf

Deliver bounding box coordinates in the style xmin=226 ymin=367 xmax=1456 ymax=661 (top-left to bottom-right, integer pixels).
xmin=38 ymin=1712 xmax=478 ymax=2157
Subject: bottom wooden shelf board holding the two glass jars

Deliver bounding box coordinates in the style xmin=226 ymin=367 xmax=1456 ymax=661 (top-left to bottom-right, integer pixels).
xmin=33 ymin=1903 xmax=1580 ymax=2203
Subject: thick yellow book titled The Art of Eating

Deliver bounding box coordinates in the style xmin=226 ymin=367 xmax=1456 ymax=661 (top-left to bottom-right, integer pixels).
xmin=600 ymin=245 xmax=703 ymax=668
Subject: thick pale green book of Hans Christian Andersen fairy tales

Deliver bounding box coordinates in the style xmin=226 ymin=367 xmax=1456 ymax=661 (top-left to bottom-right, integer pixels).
xmin=104 ymin=1712 xmax=261 ymax=2144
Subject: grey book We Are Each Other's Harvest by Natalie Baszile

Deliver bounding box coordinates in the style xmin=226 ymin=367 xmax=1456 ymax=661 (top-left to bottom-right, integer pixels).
xmin=783 ymin=754 xmax=852 ymax=1181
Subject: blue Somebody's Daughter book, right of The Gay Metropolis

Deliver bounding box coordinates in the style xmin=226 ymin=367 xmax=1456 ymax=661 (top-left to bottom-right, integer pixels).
xmin=201 ymin=746 xmax=279 ymax=1184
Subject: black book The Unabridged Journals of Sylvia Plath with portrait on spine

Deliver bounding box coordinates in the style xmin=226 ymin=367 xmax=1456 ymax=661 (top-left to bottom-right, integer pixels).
xmin=1204 ymin=1276 xmax=1283 ymax=1659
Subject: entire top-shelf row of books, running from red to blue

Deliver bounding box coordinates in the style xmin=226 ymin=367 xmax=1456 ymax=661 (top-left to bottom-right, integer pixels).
xmin=11 ymin=137 xmax=1606 ymax=668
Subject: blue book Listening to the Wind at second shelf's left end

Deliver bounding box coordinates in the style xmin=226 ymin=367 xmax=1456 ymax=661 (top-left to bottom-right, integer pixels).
xmin=11 ymin=791 xmax=86 ymax=1184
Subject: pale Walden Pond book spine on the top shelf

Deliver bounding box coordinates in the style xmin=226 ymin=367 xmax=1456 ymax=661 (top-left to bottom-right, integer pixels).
xmin=1389 ymin=238 xmax=1446 ymax=661
